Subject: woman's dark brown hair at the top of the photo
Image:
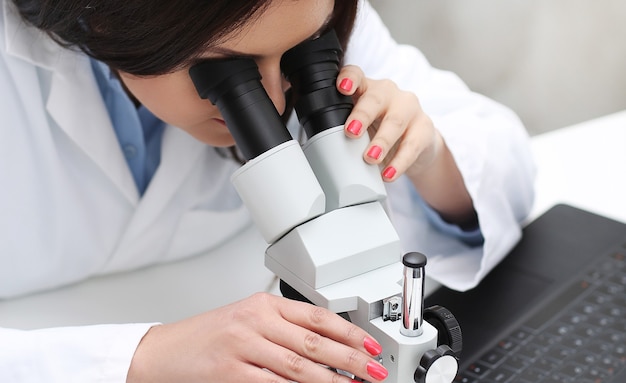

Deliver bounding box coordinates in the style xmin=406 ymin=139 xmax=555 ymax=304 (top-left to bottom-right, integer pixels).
xmin=13 ymin=0 xmax=358 ymax=76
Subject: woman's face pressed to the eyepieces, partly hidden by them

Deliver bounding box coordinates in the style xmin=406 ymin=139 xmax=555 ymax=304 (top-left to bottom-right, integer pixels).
xmin=115 ymin=0 xmax=334 ymax=146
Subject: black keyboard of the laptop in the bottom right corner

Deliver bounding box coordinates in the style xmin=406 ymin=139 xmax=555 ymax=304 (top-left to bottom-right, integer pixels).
xmin=454 ymin=244 xmax=626 ymax=383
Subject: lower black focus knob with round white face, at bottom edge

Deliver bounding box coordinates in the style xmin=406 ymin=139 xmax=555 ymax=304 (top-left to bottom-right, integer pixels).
xmin=413 ymin=345 xmax=459 ymax=383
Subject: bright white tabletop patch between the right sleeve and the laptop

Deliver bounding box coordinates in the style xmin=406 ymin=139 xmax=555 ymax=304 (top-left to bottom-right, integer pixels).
xmin=531 ymin=111 xmax=626 ymax=222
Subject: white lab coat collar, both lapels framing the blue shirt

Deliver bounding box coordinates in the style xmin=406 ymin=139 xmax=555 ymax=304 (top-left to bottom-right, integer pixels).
xmin=2 ymin=1 xmax=214 ymax=226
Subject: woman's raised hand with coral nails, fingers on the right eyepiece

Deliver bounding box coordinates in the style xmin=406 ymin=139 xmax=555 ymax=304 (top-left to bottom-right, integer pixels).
xmin=337 ymin=65 xmax=476 ymax=227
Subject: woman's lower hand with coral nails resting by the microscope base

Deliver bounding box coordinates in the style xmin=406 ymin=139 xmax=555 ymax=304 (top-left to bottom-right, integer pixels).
xmin=127 ymin=293 xmax=387 ymax=383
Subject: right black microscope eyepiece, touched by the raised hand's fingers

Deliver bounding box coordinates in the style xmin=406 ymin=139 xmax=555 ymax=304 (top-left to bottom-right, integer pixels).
xmin=280 ymin=30 xmax=353 ymax=138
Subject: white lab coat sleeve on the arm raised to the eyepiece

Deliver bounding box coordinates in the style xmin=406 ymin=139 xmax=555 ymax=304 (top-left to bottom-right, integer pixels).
xmin=345 ymin=1 xmax=535 ymax=291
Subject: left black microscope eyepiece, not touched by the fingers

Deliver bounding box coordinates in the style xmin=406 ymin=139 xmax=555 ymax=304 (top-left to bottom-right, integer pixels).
xmin=189 ymin=58 xmax=292 ymax=160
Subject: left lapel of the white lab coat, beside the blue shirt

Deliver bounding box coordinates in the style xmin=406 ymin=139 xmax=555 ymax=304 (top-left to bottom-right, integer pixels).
xmin=3 ymin=1 xmax=139 ymax=205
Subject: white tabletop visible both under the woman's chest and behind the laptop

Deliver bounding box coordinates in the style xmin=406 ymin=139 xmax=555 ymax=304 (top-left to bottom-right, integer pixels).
xmin=0 ymin=111 xmax=626 ymax=329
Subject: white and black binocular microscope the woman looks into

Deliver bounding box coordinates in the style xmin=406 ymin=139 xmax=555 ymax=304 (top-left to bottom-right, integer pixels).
xmin=189 ymin=31 xmax=462 ymax=383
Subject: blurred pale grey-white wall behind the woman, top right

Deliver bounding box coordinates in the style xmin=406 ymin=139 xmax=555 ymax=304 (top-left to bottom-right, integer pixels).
xmin=370 ymin=0 xmax=626 ymax=134
